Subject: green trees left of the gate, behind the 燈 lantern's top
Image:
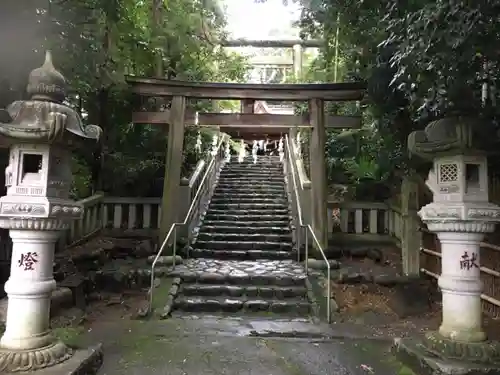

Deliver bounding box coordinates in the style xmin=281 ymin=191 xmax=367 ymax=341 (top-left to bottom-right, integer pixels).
xmin=0 ymin=0 xmax=246 ymax=196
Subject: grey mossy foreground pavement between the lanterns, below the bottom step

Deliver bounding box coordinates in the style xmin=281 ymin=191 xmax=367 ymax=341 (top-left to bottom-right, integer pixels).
xmin=72 ymin=316 xmax=413 ymax=375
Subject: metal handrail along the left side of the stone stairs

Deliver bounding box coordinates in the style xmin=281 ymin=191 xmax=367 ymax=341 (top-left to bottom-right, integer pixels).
xmin=148 ymin=136 xmax=227 ymax=313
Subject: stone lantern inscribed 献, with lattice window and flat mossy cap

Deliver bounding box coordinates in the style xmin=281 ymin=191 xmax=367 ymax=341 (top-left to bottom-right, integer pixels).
xmin=400 ymin=117 xmax=500 ymax=374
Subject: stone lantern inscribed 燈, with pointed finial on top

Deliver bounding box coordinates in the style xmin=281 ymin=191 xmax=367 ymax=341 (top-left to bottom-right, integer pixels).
xmin=0 ymin=52 xmax=101 ymax=373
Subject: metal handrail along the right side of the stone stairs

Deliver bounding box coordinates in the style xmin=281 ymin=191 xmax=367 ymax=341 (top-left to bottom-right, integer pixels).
xmin=285 ymin=135 xmax=332 ymax=323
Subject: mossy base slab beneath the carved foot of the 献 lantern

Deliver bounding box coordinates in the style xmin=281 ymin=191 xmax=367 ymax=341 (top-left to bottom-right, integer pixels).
xmin=393 ymin=338 xmax=500 ymax=375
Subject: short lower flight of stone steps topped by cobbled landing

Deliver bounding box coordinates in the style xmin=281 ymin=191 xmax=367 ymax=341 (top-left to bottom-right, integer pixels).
xmin=171 ymin=258 xmax=312 ymax=317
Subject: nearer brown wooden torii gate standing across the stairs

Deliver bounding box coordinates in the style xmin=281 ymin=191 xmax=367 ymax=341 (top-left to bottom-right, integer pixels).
xmin=127 ymin=77 xmax=365 ymax=251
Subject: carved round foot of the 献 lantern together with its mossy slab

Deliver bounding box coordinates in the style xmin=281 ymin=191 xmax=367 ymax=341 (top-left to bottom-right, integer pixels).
xmin=393 ymin=332 xmax=500 ymax=375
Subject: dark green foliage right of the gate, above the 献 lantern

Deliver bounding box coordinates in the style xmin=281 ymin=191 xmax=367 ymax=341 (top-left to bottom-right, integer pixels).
xmin=297 ymin=0 xmax=500 ymax=197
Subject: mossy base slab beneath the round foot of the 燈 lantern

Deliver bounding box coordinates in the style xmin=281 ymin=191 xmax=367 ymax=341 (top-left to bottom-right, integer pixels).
xmin=15 ymin=344 xmax=103 ymax=375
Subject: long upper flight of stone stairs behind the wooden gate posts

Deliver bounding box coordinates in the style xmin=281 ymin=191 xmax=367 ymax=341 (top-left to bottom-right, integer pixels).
xmin=191 ymin=157 xmax=293 ymax=260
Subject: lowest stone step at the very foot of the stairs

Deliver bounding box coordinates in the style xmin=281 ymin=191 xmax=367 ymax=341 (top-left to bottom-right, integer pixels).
xmin=173 ymin=295 xmax=311 ymax=315
